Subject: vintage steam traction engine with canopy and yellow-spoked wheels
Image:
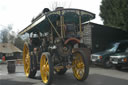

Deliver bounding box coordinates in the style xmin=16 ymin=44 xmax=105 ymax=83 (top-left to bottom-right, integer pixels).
xmin=19 ymin=8 xmax=95 ymax=85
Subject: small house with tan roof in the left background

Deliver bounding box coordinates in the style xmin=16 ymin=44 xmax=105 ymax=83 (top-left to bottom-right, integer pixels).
xmin=0 ymin=43 xmax=22 ymax=60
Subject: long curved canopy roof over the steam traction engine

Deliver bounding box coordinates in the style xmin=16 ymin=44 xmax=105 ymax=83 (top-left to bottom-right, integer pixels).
xmin=19 ymin=9 xmax=95 ymax=35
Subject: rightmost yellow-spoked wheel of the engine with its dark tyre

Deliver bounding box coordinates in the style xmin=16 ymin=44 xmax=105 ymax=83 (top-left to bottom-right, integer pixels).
xmin=72 ymin=51 xmax=89 ymax=81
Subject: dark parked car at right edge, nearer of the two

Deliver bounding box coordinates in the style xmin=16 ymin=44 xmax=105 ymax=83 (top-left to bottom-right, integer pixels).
xmin=110 ymin=48 xmax=128 ymax=70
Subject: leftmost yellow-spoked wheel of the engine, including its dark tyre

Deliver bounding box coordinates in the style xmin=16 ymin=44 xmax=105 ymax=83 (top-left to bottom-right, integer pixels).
xmin=23 ymin=43 xmax=37 ymax=78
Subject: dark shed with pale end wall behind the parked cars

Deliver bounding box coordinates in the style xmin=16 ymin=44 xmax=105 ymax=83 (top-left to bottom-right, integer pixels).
xmin=82 ymin=22 xmax=128 ymax=53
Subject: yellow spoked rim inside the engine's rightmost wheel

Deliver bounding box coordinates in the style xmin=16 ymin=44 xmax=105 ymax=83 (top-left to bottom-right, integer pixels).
xmin=72 ymin=53 xmax=85 ymax=80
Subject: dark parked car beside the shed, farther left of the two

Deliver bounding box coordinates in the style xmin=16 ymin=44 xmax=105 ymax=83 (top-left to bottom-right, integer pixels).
xmin=91 ymin=40 xmax=128 ymax=68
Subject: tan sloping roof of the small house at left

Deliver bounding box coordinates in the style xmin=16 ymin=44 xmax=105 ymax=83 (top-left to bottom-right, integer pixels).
xmin=0 ymin=43 xmax=22 ymax=53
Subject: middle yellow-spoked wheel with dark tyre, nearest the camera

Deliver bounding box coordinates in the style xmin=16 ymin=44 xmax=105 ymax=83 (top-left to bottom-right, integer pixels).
xmin=40 ymin=52 xmax=53 ymax=85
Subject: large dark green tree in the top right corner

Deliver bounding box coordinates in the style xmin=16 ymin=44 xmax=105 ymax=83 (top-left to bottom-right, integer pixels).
xmin=100 ymin=0 xmax=128 ymax=31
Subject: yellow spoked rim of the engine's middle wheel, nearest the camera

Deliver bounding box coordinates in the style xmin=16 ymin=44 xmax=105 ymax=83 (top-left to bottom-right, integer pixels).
xmin=40 ymin=55 xmax=49 ymax=83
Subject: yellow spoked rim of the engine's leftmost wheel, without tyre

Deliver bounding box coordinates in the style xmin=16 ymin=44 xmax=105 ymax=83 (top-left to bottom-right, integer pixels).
xmin=23 ymin=44 xmax=30 ymax=77
